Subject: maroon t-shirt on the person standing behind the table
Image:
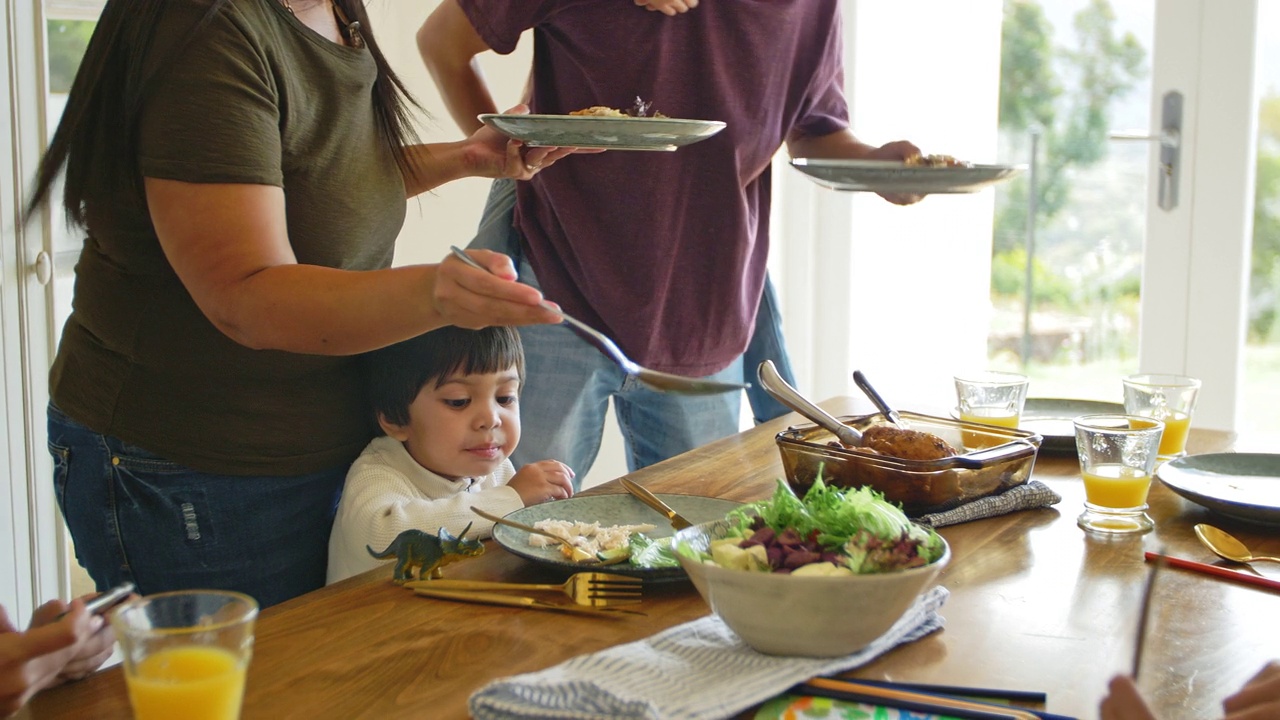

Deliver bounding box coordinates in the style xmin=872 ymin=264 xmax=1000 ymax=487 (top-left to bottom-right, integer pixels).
xmin=458 ymin=0 xmax=849 ymax=375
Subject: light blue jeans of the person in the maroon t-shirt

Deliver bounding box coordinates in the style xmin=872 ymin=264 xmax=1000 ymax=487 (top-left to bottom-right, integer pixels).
xmin=471 ymin=181 xmax=754 ymax=484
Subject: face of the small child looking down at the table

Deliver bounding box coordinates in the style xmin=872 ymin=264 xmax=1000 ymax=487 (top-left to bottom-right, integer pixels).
xmin=379 ymin=366 xmax=520 ymax=479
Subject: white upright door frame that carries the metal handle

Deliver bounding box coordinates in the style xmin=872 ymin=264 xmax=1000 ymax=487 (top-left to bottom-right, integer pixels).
xmin=1138 ymin=0 xmax=1258 ymax=430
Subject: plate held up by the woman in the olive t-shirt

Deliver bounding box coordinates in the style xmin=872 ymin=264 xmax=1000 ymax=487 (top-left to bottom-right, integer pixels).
xmin=480 ymin=113 xmax=724 ymax=151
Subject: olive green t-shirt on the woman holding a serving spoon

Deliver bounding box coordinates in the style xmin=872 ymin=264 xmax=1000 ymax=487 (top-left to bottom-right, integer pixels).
xmin=51 ymin=0 xmax=406 ymax=475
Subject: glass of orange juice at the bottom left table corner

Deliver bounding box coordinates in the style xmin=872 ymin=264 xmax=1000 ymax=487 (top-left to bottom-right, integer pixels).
xmin=111 ymin=591 xmax=257 ymax=720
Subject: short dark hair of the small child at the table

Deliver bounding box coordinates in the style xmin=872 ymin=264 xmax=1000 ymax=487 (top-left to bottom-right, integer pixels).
xmin=364 ymin=325 xmax=525 ymax=425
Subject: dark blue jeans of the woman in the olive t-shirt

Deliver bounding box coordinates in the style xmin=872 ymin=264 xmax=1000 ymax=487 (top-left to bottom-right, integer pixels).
xmin=49 ymin=404 xmax=347 ymax=607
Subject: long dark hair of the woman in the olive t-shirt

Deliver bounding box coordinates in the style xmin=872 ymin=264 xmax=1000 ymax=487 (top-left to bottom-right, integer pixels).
xmin=22 ymin=0 xmax=417 ymax=227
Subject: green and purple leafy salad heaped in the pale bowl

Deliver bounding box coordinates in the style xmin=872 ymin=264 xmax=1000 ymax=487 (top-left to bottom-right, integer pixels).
xmin=676 ymin=477 xmax=945 ymax=575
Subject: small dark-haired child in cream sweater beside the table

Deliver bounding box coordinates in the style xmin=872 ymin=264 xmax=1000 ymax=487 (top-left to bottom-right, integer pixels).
xmin=328 ymin=327 xmax=573 ymax=583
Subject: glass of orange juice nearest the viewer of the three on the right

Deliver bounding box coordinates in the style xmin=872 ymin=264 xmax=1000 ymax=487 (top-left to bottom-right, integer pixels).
xmin=1075 ymin=415 xmax=1165 ymax=533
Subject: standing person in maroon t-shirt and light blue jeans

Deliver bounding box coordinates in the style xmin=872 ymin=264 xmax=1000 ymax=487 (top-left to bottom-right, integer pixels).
xmin=417 ymin=0 xmax=919 ymax=478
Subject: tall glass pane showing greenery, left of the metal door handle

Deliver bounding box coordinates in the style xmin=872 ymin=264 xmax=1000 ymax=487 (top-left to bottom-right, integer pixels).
xmin=988 ymin=0 xmax=1155 ymax=401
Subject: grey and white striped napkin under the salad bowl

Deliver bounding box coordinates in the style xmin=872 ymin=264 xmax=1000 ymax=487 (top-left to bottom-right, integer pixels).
xmin=470 ymin=585 xmax=948 ymax=720
